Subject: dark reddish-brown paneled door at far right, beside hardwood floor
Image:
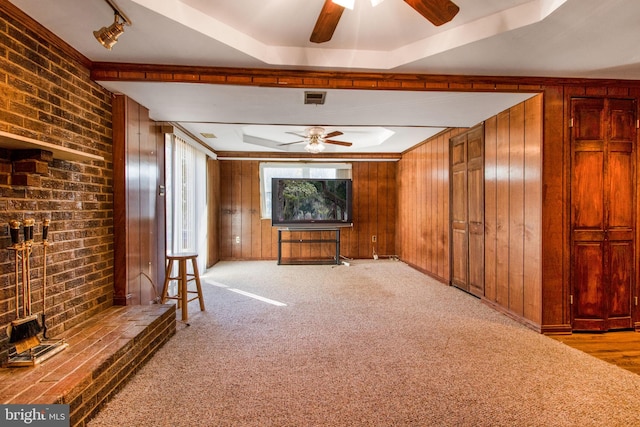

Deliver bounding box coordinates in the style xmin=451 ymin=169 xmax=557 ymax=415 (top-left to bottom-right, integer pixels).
xmin=570 ymin=98 xmax=636 ymax=331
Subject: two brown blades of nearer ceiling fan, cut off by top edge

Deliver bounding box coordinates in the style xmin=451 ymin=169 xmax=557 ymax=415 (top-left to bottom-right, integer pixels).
xmin=309 ymin=0 xmax=460 ymax=43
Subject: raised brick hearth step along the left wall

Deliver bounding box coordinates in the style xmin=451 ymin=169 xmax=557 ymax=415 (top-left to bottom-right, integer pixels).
xmin=0 ymin=304 xmax=176 ymax=426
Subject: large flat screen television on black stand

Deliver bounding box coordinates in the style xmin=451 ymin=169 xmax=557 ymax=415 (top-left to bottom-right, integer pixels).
xmin=271 ymin=178 xmax=353 ymax=228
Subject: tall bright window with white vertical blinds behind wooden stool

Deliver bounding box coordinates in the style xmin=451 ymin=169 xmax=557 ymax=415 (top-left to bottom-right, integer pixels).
xmin=165 ymin=134 xmax=207 ymax=270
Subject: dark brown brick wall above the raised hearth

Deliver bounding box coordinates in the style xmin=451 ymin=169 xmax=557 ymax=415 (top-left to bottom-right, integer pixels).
xmin=0 ymin=4 xmax=113 ymax=363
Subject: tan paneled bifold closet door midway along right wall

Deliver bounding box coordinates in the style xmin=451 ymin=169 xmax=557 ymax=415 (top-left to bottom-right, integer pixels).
xmin=450 ymin=126 xmax=484 ymax=296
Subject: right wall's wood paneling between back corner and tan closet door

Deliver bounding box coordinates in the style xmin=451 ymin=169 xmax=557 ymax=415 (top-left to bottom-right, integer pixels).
xmin=396 ymin=129 xmax=466 ymax=283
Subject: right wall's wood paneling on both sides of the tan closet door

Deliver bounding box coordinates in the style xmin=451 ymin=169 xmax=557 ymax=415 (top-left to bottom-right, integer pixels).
xmin=396 ymin=95 xmax=542 ymax=326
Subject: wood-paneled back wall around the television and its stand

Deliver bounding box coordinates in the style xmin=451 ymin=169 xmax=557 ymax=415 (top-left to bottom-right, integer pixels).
xmin=218 ymin=160 xmax=397 ymax=260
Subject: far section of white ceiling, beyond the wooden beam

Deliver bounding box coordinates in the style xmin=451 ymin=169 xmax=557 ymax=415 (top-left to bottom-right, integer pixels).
xmin=95 ymin=82 xmax=532 ymax=153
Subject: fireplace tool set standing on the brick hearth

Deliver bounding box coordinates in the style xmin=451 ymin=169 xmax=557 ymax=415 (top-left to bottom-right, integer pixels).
xmin=7 ymin=219 xmax=67 ymax=367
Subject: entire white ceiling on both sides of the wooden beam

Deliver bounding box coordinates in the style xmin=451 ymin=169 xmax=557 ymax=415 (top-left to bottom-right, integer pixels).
xmin=11 ymin=0 xmax=640 ymax=152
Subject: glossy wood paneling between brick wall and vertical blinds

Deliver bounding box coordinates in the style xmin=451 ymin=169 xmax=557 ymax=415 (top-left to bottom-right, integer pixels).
xmin=113 ymin=95 xmax=166 ymax=305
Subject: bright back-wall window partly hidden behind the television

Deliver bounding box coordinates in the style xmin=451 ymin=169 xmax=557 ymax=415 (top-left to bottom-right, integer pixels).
xmin=260 ymin=163 xmax=351 ymax=219
